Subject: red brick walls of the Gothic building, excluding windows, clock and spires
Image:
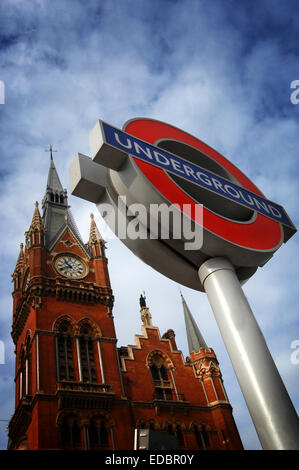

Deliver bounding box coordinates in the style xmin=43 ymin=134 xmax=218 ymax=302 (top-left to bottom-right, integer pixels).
xmin=9 ymin=196 xmax=242 ymax=450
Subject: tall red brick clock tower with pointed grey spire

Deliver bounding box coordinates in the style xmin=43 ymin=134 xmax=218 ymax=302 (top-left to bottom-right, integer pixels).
xmin=8 ymin=152 xmax=129 ymax=449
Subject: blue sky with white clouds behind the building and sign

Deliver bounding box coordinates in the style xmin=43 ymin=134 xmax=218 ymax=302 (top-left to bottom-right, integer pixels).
xmin=0 ymin=0 xmax=299 ymax=450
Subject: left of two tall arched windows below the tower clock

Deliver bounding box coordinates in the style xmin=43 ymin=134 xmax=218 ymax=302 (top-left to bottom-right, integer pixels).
xmin=56 ymin=320 xmax=75 ymax=381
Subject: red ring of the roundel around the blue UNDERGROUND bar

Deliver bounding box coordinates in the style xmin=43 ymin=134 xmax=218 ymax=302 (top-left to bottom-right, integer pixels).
xmin=124 ymin=118 xmax=282 ymax=250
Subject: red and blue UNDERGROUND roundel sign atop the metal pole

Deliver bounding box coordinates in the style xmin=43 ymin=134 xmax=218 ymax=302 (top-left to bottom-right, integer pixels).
xmin=71 ymin=118 xmax=296 ymax=290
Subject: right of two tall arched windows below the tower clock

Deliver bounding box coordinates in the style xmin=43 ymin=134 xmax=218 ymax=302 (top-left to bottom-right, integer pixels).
xmin=79 ymin=323 xmax=97 ymax=382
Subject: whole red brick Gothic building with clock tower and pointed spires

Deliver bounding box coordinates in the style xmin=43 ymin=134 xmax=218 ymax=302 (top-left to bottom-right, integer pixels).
xmin=8 ymin=154 xmax=242 ymax=450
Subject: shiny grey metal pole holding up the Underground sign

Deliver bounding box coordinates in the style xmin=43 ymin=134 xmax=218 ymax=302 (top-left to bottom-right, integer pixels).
xmin=198 ymin=258 xmax=299 ymax=450
